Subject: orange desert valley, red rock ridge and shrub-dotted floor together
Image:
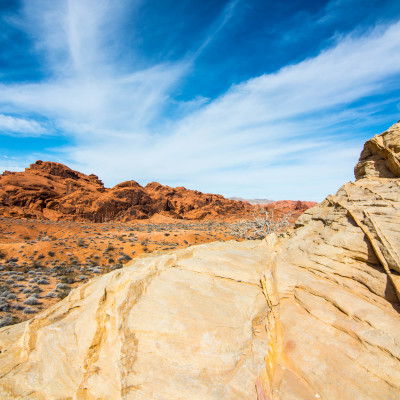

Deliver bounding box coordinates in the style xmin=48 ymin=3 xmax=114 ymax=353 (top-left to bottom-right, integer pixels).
xmin=0 ymin=161 xmax=316 ymax=326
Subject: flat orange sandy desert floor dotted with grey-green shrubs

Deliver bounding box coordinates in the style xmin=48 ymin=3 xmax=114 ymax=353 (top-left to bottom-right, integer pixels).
xmin=0 ymin=218 xmax=244 ymax=326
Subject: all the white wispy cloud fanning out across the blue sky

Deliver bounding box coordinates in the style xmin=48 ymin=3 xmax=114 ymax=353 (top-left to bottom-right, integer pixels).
xmin=0 ymin=0 xmax=400 ymax=200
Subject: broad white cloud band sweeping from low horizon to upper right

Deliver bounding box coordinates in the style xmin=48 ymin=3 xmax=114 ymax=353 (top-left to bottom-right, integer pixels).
xmin=69 ymin=24 xmax=400 ymax=200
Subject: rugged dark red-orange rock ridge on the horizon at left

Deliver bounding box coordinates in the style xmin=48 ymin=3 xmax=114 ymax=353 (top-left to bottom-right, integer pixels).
xmin=0 ymin=161 xmax=251 ymax=222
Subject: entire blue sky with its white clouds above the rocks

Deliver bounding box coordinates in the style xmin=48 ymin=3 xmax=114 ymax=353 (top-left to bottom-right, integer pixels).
xmin=0 ymin=0 xmax=400 ymax=201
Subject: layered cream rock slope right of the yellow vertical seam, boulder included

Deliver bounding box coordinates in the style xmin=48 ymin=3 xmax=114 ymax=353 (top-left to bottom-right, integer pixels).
xmin=259 ymin=124 xmax=400 ymax=400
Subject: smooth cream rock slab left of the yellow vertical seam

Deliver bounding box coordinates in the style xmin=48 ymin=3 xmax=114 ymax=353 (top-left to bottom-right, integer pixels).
xmin=0 ymin=242 xmax=270 ymax=400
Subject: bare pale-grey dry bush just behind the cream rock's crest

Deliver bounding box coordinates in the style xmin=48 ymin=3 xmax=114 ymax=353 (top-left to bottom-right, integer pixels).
xmin=230 ymin=206 xmax=292 ymax=240
